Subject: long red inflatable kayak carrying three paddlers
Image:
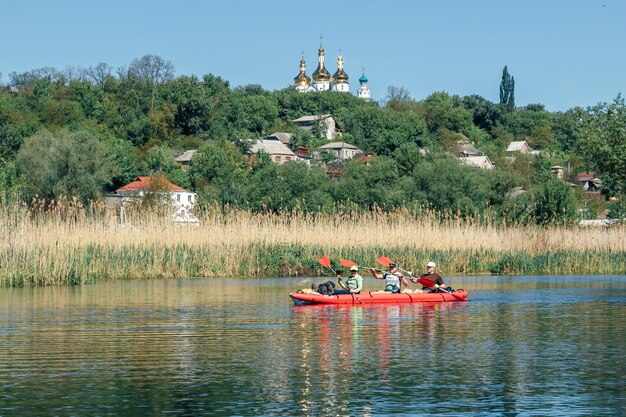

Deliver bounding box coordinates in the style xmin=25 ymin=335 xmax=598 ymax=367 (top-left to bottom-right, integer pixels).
xmin=289 ymin=290 xmax=469 ymax=305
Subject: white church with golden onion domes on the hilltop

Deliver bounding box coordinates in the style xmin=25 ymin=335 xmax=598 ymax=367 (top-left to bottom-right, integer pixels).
xmin=293 ymin=45 xmax=371 ymax=100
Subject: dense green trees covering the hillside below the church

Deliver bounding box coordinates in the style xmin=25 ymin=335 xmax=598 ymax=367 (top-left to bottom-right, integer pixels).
xmin=0 ymin=55 xmax=626 ymax=224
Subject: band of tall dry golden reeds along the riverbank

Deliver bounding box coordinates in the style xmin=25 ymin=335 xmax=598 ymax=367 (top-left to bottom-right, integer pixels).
xmin=0 ymin=200 xmax=626 ymax=286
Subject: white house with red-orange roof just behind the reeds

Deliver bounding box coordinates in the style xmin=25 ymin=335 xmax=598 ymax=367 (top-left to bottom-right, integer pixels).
xmin=107 ymin=177 xmax=197 ymax=209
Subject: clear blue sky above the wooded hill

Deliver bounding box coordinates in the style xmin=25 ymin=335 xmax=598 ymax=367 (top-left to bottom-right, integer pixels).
xmin=0 ymin=0 xmax=626 ymax=111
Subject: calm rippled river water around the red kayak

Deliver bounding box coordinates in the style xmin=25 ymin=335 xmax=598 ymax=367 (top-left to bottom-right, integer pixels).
xmin=0 ymin=276 xmax=626 ymax=416
